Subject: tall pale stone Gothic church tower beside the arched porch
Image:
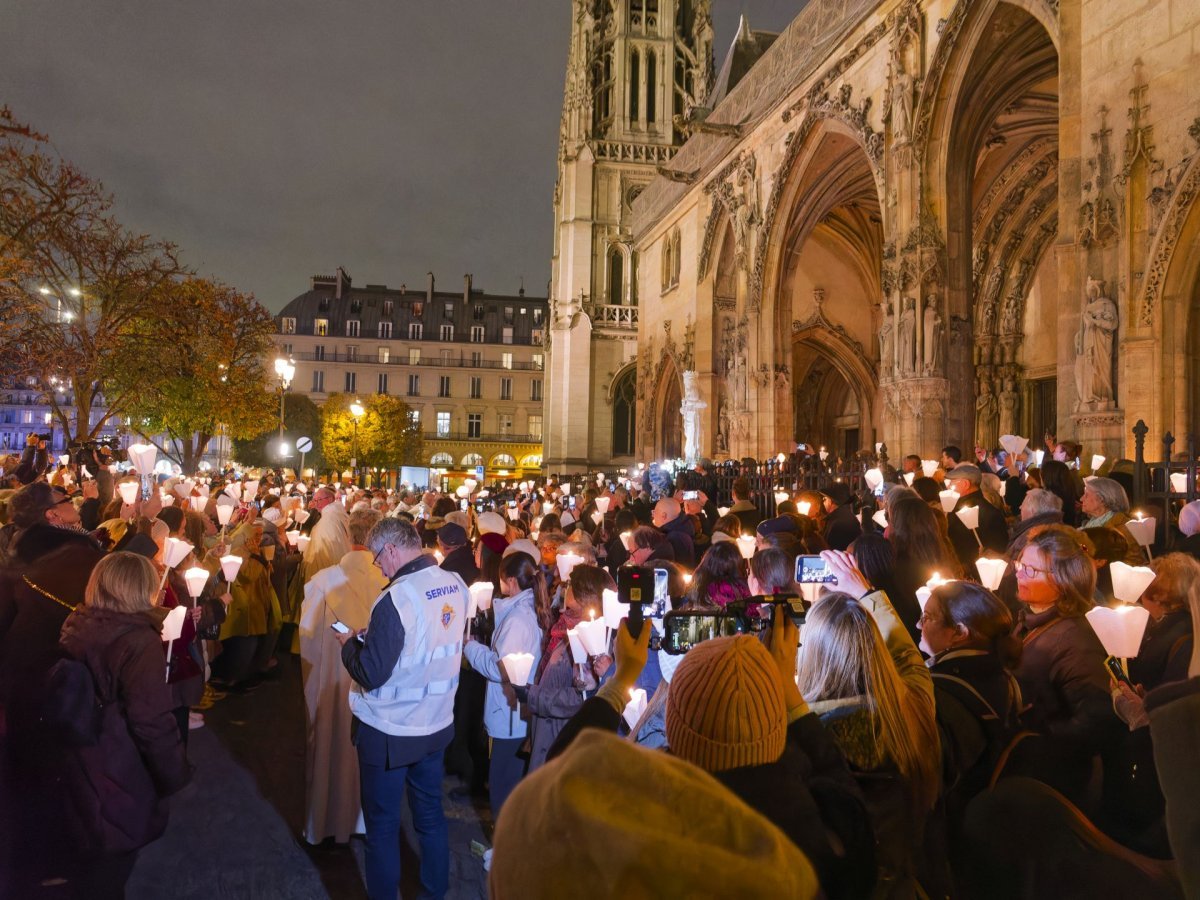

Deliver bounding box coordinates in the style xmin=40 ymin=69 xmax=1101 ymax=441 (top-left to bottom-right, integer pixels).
xmin=545 ymin=0 xmax=713 ymax=473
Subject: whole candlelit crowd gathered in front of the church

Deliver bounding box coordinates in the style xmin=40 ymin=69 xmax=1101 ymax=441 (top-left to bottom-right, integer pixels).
xmin=0 ymin=442 xmax=1200 ymax=900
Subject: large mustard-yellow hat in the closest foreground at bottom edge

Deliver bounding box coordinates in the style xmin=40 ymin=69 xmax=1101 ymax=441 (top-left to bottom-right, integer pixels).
xmin=488 ymin=734 xmax=818 ymax=900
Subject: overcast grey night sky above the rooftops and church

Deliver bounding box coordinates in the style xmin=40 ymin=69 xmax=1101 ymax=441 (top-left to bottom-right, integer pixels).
xmin=0 ymin=0 xmax=803 ymax=310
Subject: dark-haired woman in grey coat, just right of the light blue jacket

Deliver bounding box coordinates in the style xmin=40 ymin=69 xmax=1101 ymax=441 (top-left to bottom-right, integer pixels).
xmin=528 ymin=566 xmax=614 ymax=772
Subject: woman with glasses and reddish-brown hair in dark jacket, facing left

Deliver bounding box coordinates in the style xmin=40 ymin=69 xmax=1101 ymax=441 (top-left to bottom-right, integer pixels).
xmin=1013 ymin=526 xmax=1120 ymax=802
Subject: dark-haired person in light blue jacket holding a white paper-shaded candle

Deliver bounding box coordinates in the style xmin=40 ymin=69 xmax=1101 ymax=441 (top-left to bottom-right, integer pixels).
xmin=460 ymin=549 xmax=551 ymax=816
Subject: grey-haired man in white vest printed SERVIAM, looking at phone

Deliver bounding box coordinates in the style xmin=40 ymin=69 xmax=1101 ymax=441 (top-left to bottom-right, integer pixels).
xmin=338 ymin=518 xmax=467 ymax=900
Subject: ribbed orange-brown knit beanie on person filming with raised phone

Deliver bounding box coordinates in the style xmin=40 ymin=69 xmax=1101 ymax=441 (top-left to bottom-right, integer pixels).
xmin=666 ymin=635 xmax=787 ymax=772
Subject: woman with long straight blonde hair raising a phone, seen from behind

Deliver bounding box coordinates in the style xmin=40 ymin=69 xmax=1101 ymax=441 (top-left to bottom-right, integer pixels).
xmin=797 ymin=551 xmax=940 ymax=896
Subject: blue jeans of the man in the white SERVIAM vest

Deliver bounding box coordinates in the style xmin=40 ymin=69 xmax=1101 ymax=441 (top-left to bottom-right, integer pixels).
xmin=359 ymin=748 xmax=450 ymax=900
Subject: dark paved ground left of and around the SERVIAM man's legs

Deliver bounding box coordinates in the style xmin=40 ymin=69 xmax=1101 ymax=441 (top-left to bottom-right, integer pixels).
xmin=128 ymin=655 xmax=490 ymax=900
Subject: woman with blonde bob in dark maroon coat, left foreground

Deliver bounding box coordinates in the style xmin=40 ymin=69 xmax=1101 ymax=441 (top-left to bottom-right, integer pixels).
xmin=60 ymin=552 xmax=191 ymax=896
